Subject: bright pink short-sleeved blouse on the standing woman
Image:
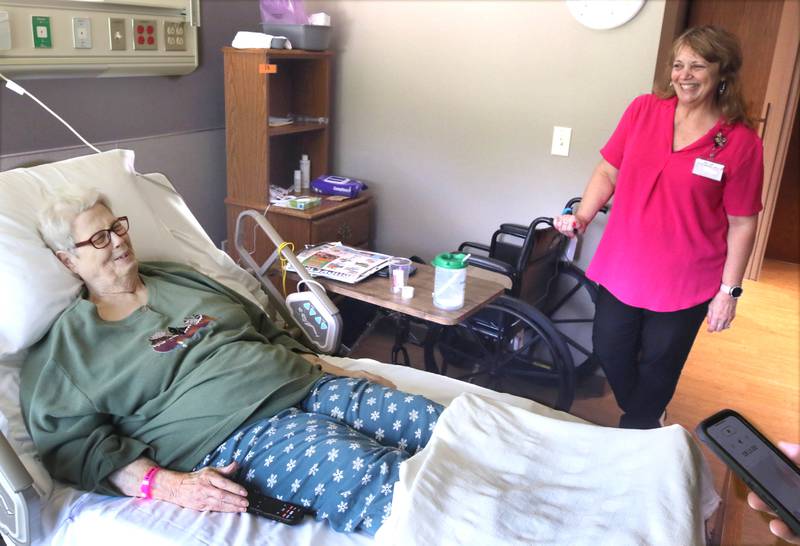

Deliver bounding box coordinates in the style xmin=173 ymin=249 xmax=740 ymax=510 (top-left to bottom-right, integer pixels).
xmin=587 ymin=95 xmax=764 ymax=312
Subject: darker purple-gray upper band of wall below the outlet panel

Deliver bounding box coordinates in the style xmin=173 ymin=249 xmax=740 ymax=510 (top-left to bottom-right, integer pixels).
xmin=0 ymin=0 xmax=259 ymax=155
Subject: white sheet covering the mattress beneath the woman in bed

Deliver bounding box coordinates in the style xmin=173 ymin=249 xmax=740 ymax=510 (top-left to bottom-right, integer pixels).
xmin=6 ymin=350 xmax=579 ymax=546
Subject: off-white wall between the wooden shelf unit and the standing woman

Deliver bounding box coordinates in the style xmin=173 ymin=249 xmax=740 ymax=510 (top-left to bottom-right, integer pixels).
xmin=307 ymin=0 xmax=664 ymax=262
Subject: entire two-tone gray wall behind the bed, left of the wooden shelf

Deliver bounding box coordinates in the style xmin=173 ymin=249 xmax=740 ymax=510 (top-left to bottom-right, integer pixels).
xmin=0 ymin=0 xmax=259 ymax=244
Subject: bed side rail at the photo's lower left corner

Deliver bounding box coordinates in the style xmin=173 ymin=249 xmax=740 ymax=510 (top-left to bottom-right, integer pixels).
xmin=0 ymin=432 xmax=40 ymax=546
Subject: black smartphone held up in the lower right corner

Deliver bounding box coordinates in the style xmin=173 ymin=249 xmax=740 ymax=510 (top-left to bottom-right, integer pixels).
xmin=696 ymin=409 xmax=800 ymax=535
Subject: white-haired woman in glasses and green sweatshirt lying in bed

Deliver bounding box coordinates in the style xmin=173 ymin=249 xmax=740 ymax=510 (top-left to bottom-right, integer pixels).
xmin=21 ymin=186 xmax=442 ymax=534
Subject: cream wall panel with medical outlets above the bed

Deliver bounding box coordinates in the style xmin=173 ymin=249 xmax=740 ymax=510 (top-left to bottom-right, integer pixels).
xmin=0 ymin=0 xmax=199 ymax=78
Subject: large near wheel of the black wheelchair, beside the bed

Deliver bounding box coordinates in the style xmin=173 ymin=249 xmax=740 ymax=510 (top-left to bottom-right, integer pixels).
xmin=425 ymin=296 xmax=575 ymax=411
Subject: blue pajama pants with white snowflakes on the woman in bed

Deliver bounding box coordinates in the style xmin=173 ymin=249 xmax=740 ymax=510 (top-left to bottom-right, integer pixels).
xmin=196 ymin=375 xmax=444 ymax=535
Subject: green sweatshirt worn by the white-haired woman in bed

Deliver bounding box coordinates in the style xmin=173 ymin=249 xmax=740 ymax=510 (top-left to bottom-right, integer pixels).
xmin=20 ymin=263 xmax=321 ymax=495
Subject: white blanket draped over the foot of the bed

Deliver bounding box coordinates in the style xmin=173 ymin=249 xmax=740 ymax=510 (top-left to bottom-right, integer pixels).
xmin=376 ymin=394 xmax=719 ymax=546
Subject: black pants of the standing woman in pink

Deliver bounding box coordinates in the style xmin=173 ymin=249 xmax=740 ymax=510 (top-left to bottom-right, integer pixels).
xmin=592 ymin=286 xmax=709 ymax=428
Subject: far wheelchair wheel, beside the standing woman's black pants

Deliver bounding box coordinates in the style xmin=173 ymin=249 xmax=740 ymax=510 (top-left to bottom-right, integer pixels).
xmin=540 ymin=261 xmax=597 ymax=376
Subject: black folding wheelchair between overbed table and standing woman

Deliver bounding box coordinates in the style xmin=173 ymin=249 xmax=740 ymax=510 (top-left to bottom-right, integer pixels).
xmin=423 ymin=198 xmax=608 ymax=411
